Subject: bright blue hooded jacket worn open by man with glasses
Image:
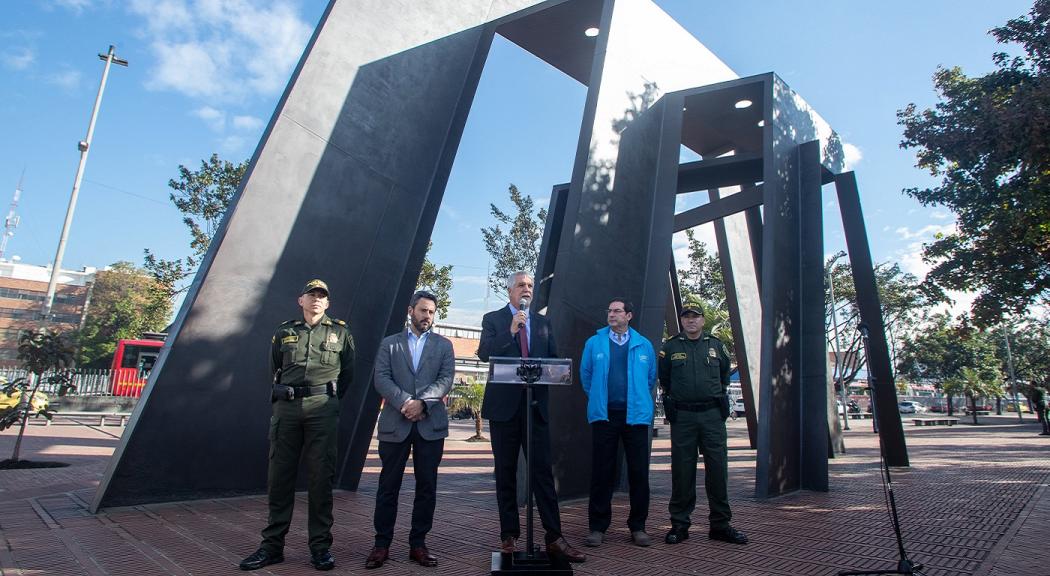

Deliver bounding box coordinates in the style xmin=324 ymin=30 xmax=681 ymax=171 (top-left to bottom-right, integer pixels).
xmin=580 ymin=326 xmax=656 ymax=426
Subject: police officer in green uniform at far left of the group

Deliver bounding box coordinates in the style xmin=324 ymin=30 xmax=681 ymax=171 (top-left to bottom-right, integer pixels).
xmin=240 ymin=280 xmax=354 ymax=570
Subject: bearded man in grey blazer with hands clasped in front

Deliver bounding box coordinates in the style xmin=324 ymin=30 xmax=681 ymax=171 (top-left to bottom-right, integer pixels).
xmin=364 ymin=291 xmax=455 ymax=569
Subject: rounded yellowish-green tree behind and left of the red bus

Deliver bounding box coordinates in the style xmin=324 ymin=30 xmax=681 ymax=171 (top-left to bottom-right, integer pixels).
xmin=79 ymin=262 xmax=171 ymax=367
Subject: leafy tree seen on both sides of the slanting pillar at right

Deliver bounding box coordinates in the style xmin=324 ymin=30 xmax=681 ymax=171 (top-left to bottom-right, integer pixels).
xmin=824 ymin=252 xmax=943 ymax=385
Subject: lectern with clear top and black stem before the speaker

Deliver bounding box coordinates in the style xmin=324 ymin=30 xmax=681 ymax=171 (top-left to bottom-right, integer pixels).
xmin=486 ymin=357 xmax=572 ymax=576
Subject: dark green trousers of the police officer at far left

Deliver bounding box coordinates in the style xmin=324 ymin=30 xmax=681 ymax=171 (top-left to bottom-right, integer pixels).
xmin=260 ymin=396 xmax=339 ymax=553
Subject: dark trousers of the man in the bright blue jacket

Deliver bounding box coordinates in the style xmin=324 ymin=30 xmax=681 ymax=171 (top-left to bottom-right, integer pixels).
xmin=587 ymin=410 xmax=649 ymax=532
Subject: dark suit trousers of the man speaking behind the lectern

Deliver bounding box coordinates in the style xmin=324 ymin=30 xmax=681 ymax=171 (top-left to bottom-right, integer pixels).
xmin=488 ymin=394 xmax=562 ymax=543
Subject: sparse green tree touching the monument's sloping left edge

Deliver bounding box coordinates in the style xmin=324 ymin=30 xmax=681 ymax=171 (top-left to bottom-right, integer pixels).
xmin=143 ymin=154 xmax=248 ymax=296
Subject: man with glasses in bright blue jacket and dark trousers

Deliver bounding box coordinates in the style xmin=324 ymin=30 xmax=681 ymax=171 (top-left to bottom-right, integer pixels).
xmin=580 ymin=297 xmax=656 ymax=547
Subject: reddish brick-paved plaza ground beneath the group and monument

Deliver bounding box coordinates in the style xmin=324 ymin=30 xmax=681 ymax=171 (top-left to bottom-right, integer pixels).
xmin=0 ymin=414 xmax=1050 ymax=576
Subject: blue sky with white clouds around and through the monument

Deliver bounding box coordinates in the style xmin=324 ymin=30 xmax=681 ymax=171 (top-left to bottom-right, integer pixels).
xmin=0 ymin=0 xmax=1031 ymax=323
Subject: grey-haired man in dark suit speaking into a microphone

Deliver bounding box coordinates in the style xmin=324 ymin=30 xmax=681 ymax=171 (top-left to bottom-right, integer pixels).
xmin=478 ymin=272 xmax=586 ymax=562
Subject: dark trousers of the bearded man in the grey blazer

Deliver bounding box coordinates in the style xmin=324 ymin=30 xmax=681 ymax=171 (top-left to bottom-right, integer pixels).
xmin=373 ymin=424 xmax=445 ymax=548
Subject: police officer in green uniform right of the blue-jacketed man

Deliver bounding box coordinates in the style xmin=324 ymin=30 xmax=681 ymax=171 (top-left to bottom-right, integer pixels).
xmin=657 ymin=304 xmax=748 ymax=545
